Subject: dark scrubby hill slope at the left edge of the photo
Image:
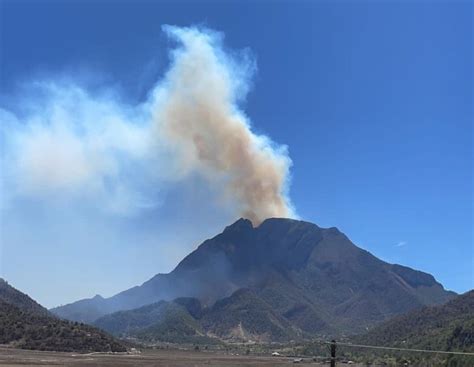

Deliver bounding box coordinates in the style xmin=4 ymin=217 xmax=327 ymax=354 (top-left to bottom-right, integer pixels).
xmin=0 ymin=279 xmax=126 ymax=352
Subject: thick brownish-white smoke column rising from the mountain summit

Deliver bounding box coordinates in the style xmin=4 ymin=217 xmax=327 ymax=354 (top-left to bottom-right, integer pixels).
xmin=155 ymin=27 xmax=292 ymax=224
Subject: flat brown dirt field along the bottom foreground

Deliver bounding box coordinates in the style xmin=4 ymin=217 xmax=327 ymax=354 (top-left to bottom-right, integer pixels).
xmin=0 ymin=348 xmax=334 ymax=367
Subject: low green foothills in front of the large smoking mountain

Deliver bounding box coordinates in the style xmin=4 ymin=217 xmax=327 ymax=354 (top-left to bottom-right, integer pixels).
xmin=94 ymin=289 xmax=301 ymax=344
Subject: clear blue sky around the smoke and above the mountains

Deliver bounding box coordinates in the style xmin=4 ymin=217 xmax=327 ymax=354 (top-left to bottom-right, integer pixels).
xmin=0 ymin=0 xmax=474 ymax=306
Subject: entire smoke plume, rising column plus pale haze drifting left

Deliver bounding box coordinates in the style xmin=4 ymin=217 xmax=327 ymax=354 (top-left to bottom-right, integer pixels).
xmin=0 ymin=26 xmax=295 ymax=224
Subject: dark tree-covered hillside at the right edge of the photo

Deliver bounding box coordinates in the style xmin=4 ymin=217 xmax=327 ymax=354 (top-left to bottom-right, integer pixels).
xmin=354 ymin=290 xmax=474 ymax=366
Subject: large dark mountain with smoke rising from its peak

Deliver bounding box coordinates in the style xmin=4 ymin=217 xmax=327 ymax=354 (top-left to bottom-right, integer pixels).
xmin=52 ymin=218 xmax=455 ymax=335
